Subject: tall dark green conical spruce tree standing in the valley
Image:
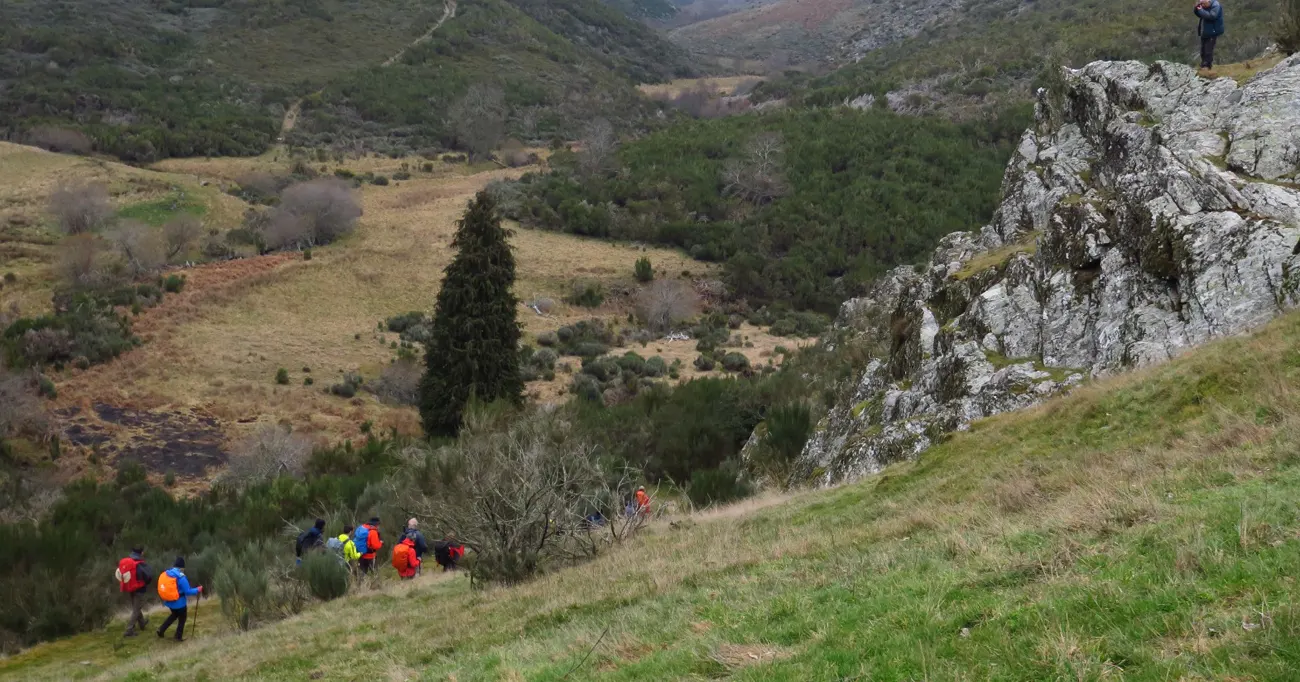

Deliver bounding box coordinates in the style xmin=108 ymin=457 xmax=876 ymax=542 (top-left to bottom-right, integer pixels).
xmin=420 ymin=192 xmax=524 ymax=436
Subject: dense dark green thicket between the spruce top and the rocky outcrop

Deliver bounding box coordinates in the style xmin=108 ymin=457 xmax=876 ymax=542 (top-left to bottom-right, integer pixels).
xmin=497 ymin=109 xmax=1027 ymax=313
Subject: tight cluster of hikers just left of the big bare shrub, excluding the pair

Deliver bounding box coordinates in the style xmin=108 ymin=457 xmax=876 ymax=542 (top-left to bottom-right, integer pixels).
xmin=294 ymin=516 xmax=465 ymax=579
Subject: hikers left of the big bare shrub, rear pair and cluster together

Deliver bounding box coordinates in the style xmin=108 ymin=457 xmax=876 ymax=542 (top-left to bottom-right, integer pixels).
xmin=114 ymin=517 xmax=465 ymax=642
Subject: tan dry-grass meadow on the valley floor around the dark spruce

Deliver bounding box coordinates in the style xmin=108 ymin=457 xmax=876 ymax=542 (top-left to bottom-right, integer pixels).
xmin=50 ymin=158 xmax=707 ymax=454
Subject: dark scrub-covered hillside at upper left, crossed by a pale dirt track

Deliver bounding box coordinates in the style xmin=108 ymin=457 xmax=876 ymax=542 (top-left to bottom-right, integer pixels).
xmin=0 ymin=0 xmax=690 ymax=161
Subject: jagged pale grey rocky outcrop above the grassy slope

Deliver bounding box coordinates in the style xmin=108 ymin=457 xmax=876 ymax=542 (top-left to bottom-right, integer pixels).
xmin=796 ymin=55 xmax=1300 ymax=483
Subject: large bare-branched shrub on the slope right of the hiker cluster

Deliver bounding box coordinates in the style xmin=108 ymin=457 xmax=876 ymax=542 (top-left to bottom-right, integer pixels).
xmin=398 ymin=410 xmax=633 ymax=583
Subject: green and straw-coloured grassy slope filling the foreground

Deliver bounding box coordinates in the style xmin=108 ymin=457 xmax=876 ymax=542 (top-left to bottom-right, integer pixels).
xmin=0 ymin=302 xmax=1300 ymax=681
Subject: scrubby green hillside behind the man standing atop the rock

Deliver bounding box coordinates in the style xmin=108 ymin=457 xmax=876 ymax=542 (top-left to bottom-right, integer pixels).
xmin=759 ymin=0 xmax=1279 ymax=117
